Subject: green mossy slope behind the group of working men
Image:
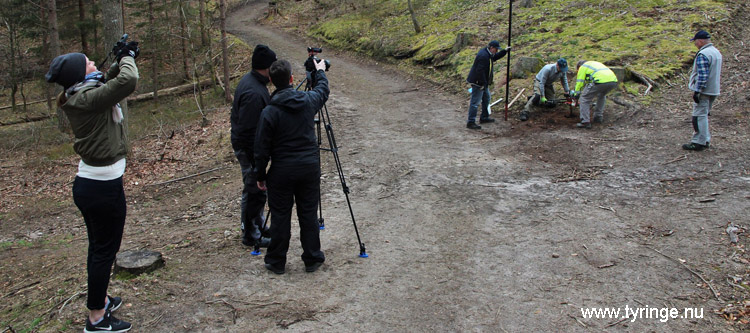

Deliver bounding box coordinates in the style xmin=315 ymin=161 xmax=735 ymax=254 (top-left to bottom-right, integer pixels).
xmin=279 ymin=0 xmax=729 ymax=85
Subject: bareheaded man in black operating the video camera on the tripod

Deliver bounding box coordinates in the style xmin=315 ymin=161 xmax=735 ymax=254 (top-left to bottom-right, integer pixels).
xmin=255 ymin=60 xmax=329 ymax=274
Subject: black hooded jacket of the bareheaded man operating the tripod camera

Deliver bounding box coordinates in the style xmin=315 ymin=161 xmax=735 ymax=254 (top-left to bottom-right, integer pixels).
xmin=255 ymin=70 xmax=330 ymax=181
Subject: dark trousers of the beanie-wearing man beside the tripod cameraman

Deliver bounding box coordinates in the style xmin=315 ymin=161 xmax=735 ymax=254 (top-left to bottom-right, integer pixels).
xmin=234 ymin=150 xmax=266 ymax=243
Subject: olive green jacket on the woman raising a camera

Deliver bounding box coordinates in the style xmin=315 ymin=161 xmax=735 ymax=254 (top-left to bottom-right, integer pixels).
xmin=57 ymin=57 xmax=138 ymax=166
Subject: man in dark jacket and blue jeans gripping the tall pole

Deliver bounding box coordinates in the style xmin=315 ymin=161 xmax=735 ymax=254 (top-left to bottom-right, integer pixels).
xmin=466 ymin=40 xmax=510 ymax=129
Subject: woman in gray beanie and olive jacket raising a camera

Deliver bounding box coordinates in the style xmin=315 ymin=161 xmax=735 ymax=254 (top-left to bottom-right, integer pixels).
xmin=45 ymin=38 xmax=140 ymax=332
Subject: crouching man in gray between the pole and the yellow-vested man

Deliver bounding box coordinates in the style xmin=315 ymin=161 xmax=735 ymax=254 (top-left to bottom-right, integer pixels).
xmin=519 ymin=58 xmax=570 ymax=121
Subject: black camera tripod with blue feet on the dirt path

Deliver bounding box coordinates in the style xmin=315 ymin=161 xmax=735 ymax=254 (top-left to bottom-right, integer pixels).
xmin=276 ymin=72 xmax=369 ymax=258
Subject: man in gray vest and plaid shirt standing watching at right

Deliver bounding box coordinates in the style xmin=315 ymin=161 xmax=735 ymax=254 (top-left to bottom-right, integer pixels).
xmin=682 ymin=30 xmax=722 ymax=151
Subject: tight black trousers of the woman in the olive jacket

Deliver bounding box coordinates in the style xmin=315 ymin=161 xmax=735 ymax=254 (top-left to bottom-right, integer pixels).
xmin=73 ymin=177 xmax=127 ymax=310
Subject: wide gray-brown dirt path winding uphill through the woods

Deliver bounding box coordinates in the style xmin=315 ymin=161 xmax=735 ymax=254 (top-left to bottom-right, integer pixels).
xmin=195 ymin=1 xmax=748 ymax=331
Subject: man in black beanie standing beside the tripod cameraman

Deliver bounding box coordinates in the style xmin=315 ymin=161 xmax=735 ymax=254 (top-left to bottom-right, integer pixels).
xmin=230 ymin=45 xmax=276 ymax=247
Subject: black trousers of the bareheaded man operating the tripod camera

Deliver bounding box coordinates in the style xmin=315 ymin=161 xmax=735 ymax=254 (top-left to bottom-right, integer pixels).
xmin=264 ymin=162 xmax=325 ymax=268
